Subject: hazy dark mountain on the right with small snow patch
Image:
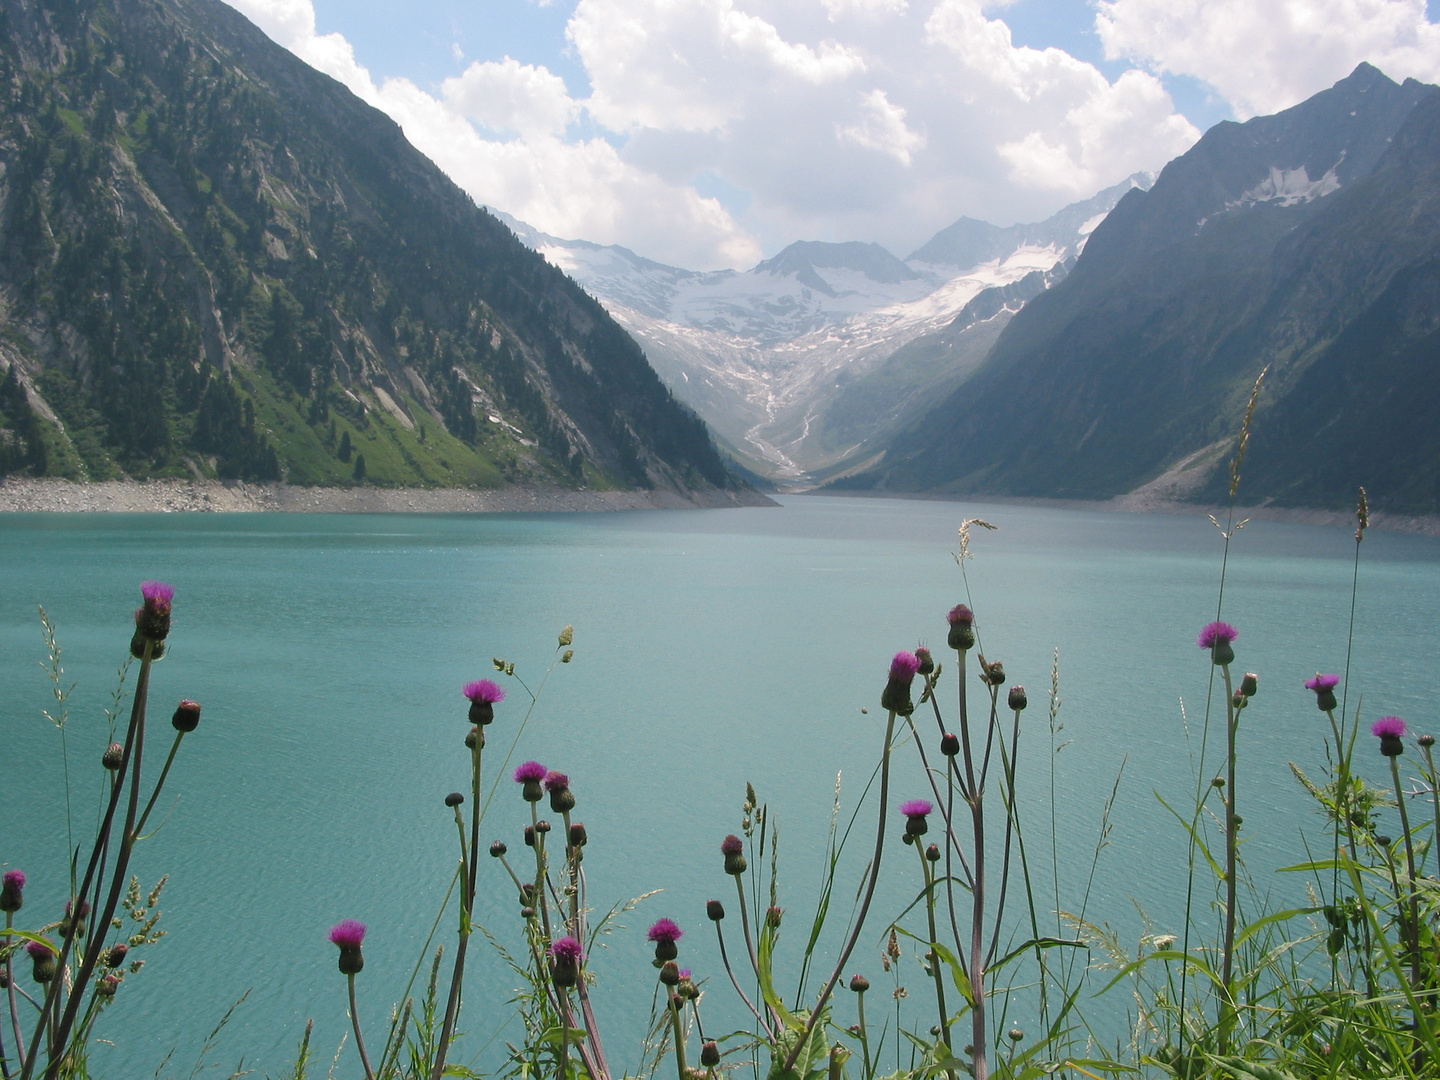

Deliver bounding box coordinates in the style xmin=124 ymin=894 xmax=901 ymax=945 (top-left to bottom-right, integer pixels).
xmin=842 ymin=65 xmax=1440 ymax=513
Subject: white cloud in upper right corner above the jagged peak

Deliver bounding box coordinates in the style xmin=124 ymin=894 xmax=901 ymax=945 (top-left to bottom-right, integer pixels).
xmin=1096 ymin=0 xmax=1440 ymax=118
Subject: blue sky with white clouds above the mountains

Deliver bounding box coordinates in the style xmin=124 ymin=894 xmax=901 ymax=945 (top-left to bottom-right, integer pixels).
xmin=229 ymin=0 xmax=1440 ymax=269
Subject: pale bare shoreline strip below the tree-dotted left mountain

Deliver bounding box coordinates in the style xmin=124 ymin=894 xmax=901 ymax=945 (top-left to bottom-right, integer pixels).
xmin=0 ymin=477 xmax=778 ymax=514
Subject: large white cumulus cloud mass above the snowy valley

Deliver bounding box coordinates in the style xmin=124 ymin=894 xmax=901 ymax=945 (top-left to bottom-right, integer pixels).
xmin=221 ymin=0 xmax=1215 ymax=269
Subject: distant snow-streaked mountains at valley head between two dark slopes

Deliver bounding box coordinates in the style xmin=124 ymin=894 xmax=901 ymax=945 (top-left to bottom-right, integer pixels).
xmin=498 ymin=174 xmax=1152 ymax=485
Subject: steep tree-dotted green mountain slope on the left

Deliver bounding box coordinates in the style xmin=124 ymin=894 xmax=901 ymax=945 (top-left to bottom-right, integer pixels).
xmin=0 ymin=0 xmax=739 ymax=495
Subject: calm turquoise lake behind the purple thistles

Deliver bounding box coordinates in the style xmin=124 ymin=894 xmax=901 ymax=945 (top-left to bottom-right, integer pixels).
xmin=0 ymin=497 xmax=1440 ymax=1077
